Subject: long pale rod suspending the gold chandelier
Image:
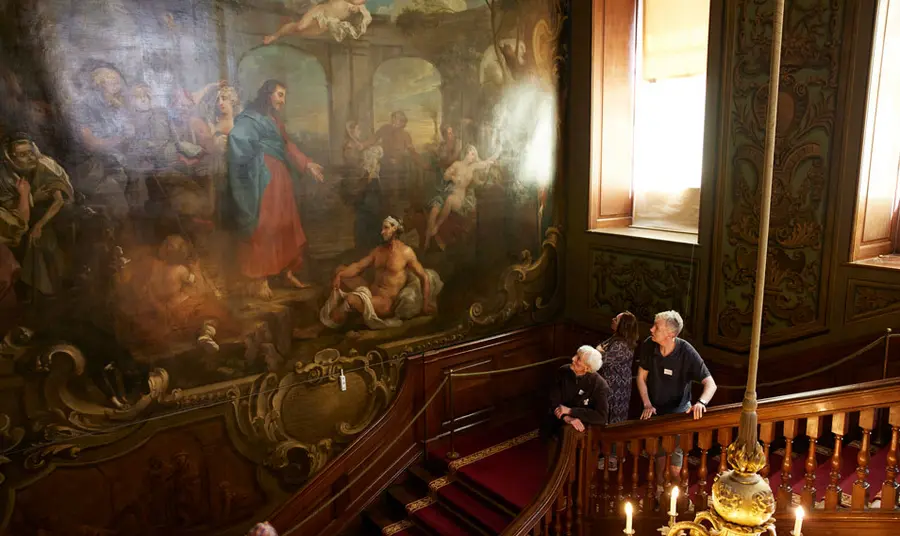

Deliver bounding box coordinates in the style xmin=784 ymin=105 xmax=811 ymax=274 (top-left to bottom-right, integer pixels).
xmin=738 ymin=0 xmax=784 ymax=452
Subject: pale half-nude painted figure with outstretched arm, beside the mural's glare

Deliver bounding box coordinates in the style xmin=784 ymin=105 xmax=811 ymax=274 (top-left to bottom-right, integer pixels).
xmin=425 ymin=145 xmax=497 ymax=250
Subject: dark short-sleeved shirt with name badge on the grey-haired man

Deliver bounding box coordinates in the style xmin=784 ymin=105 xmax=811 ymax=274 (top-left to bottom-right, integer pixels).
xmin=639 ymin=337 xmax=710 ymax=415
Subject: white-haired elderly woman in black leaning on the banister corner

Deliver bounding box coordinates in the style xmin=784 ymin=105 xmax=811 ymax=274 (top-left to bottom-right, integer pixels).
xmin=541 ymin=346 xmax=609 ymax=456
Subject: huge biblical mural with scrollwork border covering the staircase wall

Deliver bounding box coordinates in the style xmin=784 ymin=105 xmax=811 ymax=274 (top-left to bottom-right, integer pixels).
xmin=0 ymin=0 xmax=565 ymax=534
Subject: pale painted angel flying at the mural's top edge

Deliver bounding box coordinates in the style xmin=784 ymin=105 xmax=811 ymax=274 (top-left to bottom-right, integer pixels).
xmin=263 ymin=0 xmax=372 ymax=45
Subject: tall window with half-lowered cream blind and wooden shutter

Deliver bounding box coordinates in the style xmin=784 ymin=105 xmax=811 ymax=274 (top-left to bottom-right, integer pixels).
xmin=590 ymin=0 xmax=710 ymax=234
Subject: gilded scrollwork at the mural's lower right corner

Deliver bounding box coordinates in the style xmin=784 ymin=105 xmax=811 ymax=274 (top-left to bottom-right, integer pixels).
xmin=469 ymin=227 xmax=563 ymax=326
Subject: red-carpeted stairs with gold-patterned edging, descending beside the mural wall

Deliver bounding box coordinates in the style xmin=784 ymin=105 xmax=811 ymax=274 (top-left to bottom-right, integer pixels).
xmin=364 ymin=424 xmax=547 ymax=536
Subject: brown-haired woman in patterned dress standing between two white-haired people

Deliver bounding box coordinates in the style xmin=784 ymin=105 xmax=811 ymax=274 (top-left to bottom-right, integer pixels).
xmin=597 ymin=311 xmax=638 ymax=471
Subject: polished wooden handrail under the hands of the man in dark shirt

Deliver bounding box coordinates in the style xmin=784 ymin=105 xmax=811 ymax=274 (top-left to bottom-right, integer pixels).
xmin=599 ymin=378 xmax=900 ymax=441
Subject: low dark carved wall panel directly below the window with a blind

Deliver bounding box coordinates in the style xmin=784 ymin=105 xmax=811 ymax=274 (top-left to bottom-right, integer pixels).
xmin=588 ymin=248 xmax=697 ymax=332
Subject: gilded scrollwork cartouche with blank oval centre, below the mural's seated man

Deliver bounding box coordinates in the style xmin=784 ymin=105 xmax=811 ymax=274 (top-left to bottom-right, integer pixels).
xmin=229 ymin=348 xmax=402 ymax=481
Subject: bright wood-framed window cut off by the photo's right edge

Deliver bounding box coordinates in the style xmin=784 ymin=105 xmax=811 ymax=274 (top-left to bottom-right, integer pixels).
xmin=853 ymin=0 xmax=900 ymax=260
